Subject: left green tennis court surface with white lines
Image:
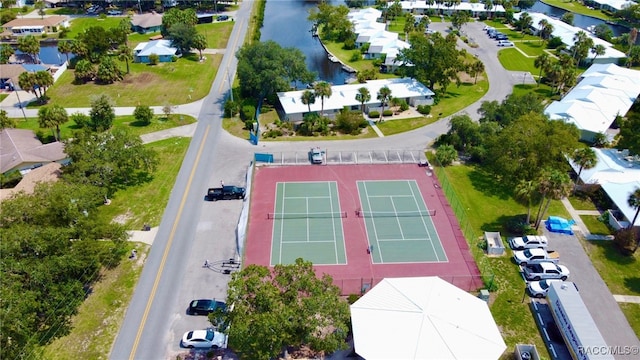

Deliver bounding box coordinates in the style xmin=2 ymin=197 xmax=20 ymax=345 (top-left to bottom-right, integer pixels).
xmin=267 ymin=181 xmax=347 ymax=266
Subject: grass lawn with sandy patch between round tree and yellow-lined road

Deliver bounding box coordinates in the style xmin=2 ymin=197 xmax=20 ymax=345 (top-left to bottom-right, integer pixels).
xmin=99 ymin=137 xmax=191 ymax=229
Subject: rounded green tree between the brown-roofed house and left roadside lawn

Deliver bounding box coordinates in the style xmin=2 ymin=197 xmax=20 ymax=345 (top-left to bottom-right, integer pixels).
xmin=63 ymin=129 xmax=157 ymax=196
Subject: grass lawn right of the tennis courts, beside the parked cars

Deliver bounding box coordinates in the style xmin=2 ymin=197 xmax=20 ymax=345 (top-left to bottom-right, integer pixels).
xmin=438 ymin=165 xmax=566 ymax=358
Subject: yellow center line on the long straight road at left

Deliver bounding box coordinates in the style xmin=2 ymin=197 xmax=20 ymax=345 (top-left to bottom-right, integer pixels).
xmin=129 ymin=125 xmax=210 ymax=360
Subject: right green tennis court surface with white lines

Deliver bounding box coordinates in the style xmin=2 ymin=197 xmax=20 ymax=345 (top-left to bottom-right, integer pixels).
xmin=357 ymin=180 xmax=448 ymax=264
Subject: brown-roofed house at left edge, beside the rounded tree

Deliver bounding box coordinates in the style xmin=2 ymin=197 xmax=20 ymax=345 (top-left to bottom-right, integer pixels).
xmin=0 ymin=129 xmax=68 ymax=174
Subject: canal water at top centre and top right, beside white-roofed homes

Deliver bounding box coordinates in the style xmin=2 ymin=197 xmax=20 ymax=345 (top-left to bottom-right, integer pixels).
xmin=260 ymin=0 xmax=629 ymax=84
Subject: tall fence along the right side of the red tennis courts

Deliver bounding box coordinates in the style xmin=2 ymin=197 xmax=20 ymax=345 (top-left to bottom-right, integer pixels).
xmin=430 ymin=156 xmax=497 ymax=291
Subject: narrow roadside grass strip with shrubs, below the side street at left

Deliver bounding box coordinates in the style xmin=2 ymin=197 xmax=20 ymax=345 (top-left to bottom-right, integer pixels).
xmin=17 ymin=114 xmax=196 ymax=139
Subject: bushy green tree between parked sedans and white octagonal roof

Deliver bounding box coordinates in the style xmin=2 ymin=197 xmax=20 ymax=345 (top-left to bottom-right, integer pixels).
xmin=225 ymin=259 xmax=349 ymax=359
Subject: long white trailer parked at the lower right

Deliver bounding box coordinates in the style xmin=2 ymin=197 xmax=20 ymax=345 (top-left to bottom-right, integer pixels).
xmin=547 ymin=282 xmax=614 ymax=360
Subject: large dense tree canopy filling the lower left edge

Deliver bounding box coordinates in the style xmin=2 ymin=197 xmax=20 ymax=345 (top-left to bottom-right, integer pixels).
xmin=0 ymin=181 xmax=127 ymax=359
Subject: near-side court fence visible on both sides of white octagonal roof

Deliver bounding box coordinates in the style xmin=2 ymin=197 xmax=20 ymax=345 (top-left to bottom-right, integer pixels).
xmin=333 ymin=275 xmax=485 ymax=296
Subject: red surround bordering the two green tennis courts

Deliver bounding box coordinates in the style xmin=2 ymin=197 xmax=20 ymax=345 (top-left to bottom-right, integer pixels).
xmin=244 ymin=164 xmax=483 ymax=295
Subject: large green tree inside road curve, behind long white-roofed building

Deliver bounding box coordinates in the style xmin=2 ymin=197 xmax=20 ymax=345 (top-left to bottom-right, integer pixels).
xmin=398 ymin=32 xmax=465 ymax=92
